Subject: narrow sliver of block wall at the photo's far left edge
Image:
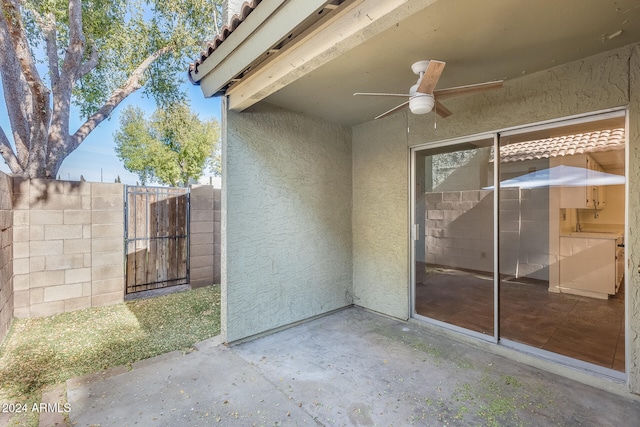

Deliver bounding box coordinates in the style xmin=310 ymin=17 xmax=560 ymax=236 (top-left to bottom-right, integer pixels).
xmin=0 ymin=172 xmax=13 ymax=342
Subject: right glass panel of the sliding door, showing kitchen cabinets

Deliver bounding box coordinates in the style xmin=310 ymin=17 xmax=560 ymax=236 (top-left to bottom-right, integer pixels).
xmin=499 ymin=116 xmax=625 ymax=372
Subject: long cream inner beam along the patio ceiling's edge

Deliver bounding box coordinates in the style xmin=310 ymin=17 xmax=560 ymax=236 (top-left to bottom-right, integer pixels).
xmin=221 ymin=0 xmax=438 ymax=111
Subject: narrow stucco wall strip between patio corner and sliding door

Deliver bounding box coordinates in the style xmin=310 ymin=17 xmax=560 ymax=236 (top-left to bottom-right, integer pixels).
xmin=353 ymin=115 xmax=409 ymax=319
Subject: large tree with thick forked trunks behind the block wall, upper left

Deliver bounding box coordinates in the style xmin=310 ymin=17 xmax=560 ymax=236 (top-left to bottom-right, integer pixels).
xmin=0 ymin=0 xmax=222 ymax=178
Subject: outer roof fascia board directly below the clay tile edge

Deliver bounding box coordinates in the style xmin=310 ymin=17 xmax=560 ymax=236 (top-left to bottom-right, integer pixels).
xmin=192 ymin=0 xmax=327 ymax=93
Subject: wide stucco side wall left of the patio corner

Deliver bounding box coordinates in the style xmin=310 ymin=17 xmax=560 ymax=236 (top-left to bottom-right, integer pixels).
xmin=222 ymin=103 xmax=352 ymax=341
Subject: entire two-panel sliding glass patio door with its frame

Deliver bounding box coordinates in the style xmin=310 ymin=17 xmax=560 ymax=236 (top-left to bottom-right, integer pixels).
xmin=412 ymin=111 xmax=626 ymax=378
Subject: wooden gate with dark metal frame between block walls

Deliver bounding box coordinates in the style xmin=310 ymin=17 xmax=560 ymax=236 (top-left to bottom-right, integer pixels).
xmin=124 ymin=186 xmax=189 ymax=294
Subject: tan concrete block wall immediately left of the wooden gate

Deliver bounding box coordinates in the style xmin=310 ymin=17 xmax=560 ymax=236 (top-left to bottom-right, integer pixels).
xmin=13 ymin=178 xmax=124 ymax=317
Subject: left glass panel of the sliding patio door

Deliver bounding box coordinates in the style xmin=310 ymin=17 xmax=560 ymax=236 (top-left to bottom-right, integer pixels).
xmin=413 ymin=137 xmax=495 ymax=337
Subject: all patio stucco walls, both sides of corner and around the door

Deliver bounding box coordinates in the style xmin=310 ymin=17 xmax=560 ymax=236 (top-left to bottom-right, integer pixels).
xmin=222 ymin=45 xmax=640 ymax=394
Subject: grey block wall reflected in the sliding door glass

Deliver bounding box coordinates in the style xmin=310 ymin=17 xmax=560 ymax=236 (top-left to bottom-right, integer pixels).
xmin=425 ymin=188 xmax=550 ymax=280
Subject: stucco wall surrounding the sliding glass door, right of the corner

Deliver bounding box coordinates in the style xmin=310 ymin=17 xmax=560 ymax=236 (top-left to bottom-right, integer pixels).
xmin=353 ymin=45 xmax=640 ymax=393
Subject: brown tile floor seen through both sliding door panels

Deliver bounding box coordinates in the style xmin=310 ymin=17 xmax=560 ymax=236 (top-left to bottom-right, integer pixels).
xmin=415 ymin=268 xmax=625 ymax=372
